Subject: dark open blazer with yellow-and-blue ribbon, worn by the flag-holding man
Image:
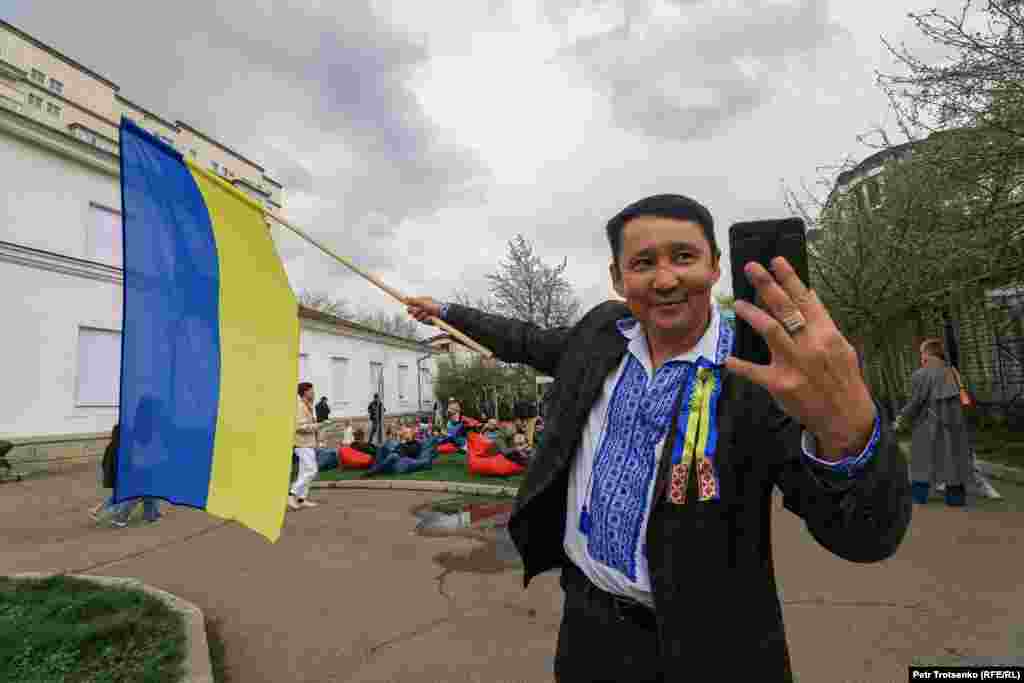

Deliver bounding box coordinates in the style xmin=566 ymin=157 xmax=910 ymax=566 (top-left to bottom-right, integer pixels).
xmin=445 ymin=301 xmax=911 ymax=681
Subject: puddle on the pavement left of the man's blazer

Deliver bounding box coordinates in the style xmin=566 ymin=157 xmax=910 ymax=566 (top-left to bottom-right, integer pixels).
xmin=413 ymin=501 xmax=522 ymax=573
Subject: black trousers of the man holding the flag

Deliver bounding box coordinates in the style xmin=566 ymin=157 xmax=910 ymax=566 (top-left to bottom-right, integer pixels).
xmin=555 ymin=565 xmax=665 ymax=683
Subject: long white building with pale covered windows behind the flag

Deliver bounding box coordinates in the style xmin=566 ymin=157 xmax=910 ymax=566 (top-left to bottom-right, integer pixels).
xmin=0 ymin=92 xmax=434 ymax=460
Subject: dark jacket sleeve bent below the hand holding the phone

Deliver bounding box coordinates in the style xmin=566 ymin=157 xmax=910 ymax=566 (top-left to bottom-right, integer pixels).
xmin=755 ymin=393 xmax=911 ymax=562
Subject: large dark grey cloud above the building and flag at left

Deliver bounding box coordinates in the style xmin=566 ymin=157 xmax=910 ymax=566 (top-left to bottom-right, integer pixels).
xmin=5 ymin=0 xmax=486 ymax=268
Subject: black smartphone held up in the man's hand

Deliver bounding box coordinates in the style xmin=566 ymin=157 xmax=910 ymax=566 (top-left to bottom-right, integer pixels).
xmin=729 ymin=218 xmax=808 ymax=365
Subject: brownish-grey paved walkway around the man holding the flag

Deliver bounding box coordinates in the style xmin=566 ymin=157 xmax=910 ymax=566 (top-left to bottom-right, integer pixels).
xmin=0 ymin=468 xmax=1024 ymax=683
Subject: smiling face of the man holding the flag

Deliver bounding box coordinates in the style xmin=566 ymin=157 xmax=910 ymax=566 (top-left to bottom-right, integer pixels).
xmin=610 ymin=216 xmax=722 ymax=337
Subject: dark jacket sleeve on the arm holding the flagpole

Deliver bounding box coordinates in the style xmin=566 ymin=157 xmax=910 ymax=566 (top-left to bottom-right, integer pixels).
xmin=444 ymin=303 xmax=569 ymax=376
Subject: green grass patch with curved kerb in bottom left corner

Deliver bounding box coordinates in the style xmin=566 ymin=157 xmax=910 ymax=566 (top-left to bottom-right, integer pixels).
xmin=0 ymin=577 xmax=185 ymax=683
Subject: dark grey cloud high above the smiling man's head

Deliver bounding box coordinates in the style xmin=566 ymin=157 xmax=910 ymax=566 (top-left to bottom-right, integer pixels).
xmin=549 ymin=0 xmax=843 ymax=140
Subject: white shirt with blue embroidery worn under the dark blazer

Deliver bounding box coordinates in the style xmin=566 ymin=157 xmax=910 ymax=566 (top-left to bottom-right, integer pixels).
xmin=563 ymin=305 xmax=881 ymax=607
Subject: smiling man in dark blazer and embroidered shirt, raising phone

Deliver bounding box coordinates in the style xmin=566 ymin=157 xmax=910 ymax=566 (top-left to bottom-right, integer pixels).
xmin=407 ymin=195 xmax=912 ymax=683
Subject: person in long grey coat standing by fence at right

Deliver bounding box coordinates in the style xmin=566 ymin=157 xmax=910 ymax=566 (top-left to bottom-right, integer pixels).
xmin=896 ymin=339 xmax=971 ymax=506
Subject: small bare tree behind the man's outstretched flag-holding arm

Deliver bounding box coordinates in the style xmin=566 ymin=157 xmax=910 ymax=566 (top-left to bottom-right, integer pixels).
xmin=487 ymin=234 xmax=582 ymax=329
